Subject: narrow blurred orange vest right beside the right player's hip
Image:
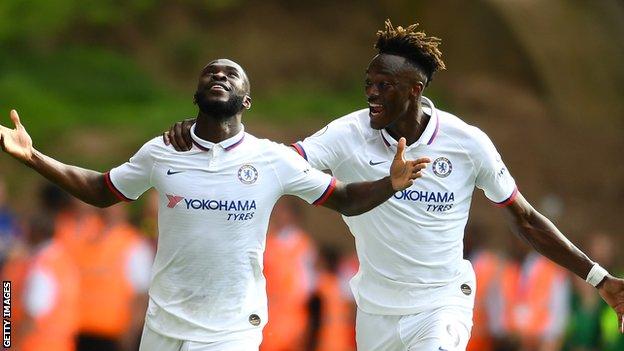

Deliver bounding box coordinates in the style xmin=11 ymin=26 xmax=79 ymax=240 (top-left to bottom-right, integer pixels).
xmin=466 ymin=251 xmax=505 ymax=351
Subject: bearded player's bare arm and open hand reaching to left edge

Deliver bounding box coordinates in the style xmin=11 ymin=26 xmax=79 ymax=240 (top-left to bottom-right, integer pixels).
xmin=0 ymin=110 xmax=119 ymax=207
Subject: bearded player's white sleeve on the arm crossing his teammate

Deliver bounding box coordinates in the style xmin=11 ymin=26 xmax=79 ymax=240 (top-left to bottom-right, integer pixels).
xmin=274 ymin=145 xmax=336 ymax=205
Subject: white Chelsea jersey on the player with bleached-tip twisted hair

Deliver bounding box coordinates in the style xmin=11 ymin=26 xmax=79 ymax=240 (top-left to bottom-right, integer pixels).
xmin=293 ymin=98 xmax=517 ymax=314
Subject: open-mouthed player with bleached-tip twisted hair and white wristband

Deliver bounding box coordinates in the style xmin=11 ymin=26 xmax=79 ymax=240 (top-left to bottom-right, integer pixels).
xmin=165 ymin=21 xmax=624 ymax=351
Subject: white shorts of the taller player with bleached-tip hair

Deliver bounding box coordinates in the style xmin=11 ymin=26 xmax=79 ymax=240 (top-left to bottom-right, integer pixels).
xmin=355 ymin=306 xmax=472 ymax=351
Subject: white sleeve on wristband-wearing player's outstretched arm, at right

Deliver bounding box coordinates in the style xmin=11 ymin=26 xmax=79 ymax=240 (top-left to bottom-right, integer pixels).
xmin=474 ymin=128 xmax=518 ymax=206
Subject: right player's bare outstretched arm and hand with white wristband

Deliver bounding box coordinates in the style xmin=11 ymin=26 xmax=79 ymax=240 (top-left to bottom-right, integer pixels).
xmin=505 ymin=194 xmax=624 ymax=333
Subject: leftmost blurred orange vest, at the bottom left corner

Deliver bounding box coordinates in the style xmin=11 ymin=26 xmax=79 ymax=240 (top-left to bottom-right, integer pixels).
xmin=22 ymin=241 xmax=79 ymax=351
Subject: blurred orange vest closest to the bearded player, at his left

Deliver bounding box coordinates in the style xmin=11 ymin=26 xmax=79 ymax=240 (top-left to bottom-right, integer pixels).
xmin=77 ymin=224 xmax=146 ymax=338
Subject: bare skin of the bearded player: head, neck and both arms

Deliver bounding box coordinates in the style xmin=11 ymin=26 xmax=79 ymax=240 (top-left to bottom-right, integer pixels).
xmin=0 ymin=59 xmax=430 ymax=216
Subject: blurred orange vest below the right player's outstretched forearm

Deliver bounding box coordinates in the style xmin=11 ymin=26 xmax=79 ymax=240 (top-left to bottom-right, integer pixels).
xmin=502 ymin=256 xmax=566 ymax=339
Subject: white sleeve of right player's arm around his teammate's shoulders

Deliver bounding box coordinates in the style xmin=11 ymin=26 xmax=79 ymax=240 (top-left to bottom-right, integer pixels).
xmin=291 ymin=117 xmax=349 ymax=171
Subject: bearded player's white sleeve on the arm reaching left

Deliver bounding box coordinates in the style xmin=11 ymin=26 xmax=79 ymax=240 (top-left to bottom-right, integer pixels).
xmin=104 ymin=142 xmax=154 ymax=201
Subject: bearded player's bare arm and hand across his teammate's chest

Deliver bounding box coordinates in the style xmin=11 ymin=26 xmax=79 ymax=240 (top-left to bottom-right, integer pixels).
xmin=323 ymin=138 xmax=431 ymax=216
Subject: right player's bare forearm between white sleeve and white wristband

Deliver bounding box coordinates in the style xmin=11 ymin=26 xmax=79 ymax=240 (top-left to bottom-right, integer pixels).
xmin=504 ymin=205 xmax=594 ymax=279
